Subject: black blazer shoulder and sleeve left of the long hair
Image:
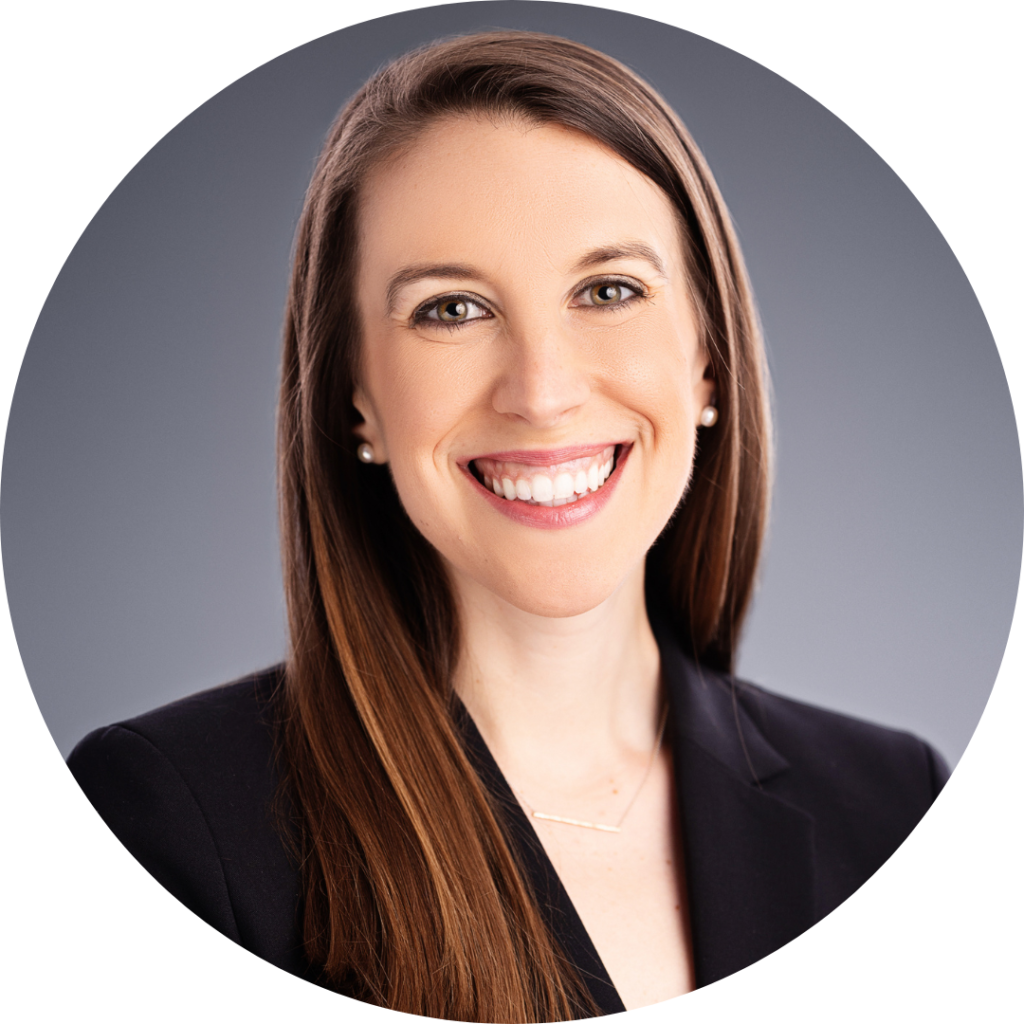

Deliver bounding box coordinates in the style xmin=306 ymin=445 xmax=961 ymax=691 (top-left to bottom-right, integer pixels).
xmin=68 ymin=667 xmax=301 ymax=973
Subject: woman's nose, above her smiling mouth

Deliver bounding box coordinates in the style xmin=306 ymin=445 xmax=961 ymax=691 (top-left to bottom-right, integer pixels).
xmin=492 ymin=323 xmax=591 ymax=428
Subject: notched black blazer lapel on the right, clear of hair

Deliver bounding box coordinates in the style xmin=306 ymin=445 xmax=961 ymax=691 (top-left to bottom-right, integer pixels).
xmin=658 ymin=634 xmax=817 ymax=986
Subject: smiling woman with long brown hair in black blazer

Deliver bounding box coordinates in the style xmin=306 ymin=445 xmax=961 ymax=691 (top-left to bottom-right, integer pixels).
xmin=70 ymin=33 xmax=945 ymax=1021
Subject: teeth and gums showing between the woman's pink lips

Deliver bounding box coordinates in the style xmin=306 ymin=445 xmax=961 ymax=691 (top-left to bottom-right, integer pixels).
xmin=469 ymin=444 xmax=618 ymax=508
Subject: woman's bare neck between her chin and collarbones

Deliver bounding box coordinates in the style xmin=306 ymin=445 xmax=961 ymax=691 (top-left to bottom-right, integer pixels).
xmin=454 ymin=563 xmax=659 ymax=776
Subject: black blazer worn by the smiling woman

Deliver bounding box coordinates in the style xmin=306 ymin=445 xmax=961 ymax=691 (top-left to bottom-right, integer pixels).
xmin=68 ymin=636 xmax=948 ymax=1013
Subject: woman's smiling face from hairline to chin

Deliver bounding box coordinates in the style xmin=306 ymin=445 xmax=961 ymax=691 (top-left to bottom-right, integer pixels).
xmin=354 ymin=116 xmax=713 ymax=616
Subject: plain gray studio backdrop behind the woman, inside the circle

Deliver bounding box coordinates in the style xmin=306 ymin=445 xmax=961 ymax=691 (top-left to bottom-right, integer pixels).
xmin=0 ymin=2 xmax=1022 ymax=762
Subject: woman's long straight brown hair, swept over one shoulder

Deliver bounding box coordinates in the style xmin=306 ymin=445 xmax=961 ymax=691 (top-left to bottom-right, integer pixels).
xmin=279 ymin=32 xmax=770 ymax=1022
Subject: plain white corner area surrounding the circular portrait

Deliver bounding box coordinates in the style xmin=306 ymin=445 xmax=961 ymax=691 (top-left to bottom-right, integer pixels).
xmin=0 ymin=0 xmax=1024 ymax=1024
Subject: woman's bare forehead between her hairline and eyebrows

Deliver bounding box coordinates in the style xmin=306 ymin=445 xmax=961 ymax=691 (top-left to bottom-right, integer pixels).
xmin=359 ymin=115 xmax=682 ymax=273
